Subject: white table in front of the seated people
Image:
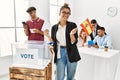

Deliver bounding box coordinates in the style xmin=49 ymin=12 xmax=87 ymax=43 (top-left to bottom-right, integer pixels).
xmin=75 ymin=47 xmax=119 ymax=80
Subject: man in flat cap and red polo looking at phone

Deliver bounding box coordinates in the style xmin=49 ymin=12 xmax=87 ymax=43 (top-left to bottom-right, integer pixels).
xmin=23 ymin=7 xmax=50 ymax=41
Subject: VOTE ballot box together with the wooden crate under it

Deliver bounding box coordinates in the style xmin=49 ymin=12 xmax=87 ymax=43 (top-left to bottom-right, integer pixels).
xmin=9 ymin=41 xmax=52 ymax=80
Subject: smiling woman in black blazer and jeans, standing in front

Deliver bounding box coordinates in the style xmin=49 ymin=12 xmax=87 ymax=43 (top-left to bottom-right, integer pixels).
xmin=45 ymin=4 xmax=81 ymax=80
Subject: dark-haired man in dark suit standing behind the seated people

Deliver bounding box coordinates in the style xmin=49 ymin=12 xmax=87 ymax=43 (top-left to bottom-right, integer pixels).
xmin=90 ymin=19 xmax=100 ymax=40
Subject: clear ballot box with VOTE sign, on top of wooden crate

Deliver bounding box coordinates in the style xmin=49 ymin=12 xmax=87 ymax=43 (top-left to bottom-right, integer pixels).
xmin=12 ymin=41 xmax=50 ymax=67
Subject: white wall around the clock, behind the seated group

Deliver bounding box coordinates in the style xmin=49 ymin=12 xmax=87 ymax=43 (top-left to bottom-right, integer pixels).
xmin=67 ymin=0 xmax=120 ymax=50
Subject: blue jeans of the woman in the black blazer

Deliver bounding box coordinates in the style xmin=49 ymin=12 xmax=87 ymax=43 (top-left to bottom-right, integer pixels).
xmin=56 ymin=48 xmax=77 ymax=80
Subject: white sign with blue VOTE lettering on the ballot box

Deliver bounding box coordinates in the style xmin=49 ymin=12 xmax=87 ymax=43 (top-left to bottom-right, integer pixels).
xmin=13 ymin=48 xmax=38 ymax=65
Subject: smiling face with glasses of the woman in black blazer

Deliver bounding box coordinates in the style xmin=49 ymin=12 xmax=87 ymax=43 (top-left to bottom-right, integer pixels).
xmin=60 ymin=8 xmax=70 ymax=21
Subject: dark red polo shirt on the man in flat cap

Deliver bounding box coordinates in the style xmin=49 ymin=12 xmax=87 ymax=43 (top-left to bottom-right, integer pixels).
xmin=26 ymin=18 xmax=44 ymax=41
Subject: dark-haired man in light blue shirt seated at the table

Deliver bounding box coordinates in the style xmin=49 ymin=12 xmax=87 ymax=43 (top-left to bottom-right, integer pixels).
xmin=93 ymin=27 xmax=112 ymax=49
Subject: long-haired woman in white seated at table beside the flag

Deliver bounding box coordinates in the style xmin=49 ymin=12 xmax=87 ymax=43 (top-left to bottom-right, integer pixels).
xmin=78 ymin=29 xmax=91 ymax=47
